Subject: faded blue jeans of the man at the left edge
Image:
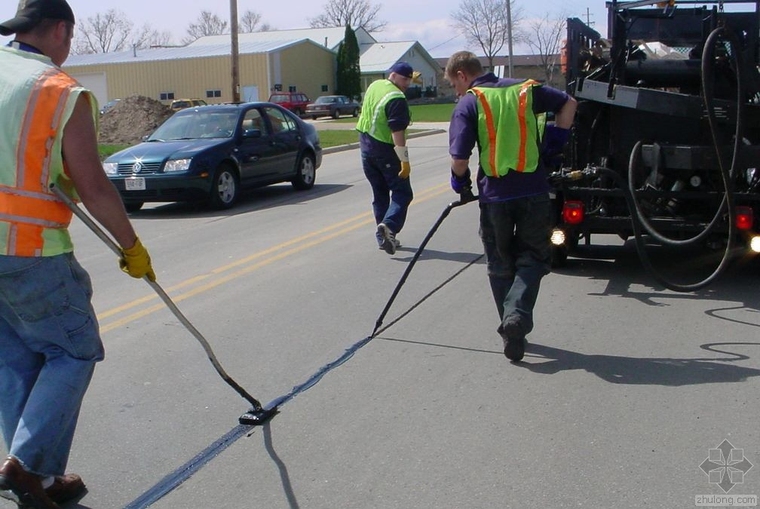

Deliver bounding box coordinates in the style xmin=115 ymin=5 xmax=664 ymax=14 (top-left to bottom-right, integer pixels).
xmin=0 ymin=254 xmax=103 ymax=476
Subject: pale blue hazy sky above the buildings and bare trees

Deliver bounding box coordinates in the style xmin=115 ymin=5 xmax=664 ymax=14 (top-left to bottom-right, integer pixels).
xmin=0 ymin=0 xmax=606 ymax=57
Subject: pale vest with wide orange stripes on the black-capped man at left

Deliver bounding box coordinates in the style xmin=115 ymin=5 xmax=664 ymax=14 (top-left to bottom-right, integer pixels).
xmin=0 ymin=47 xmax=97 ymax=257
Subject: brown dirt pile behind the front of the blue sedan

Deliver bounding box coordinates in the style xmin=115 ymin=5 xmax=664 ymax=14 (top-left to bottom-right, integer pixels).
xmin=99 ymin=95 xmax=173 ymax=145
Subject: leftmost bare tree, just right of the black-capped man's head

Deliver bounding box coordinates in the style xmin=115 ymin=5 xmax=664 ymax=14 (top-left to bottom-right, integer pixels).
xmin=71 ymin=9 xmax=134 ymax=55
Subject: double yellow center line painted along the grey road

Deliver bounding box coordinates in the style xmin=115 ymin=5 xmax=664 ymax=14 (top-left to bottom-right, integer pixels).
xmin=98 ymin=184 xmax=448 ymax=333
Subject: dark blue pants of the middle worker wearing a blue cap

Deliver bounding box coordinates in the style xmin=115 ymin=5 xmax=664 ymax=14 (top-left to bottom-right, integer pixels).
xmin=362 ymin=152 xmax=414 ymax=243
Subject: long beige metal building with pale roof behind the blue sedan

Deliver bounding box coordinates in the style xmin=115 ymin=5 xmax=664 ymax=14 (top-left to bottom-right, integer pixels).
xmin=64 ymin=39 xmax=336 ymax=108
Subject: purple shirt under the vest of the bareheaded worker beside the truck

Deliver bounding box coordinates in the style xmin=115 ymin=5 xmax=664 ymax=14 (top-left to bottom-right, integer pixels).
xmin=449 ymin=73 xmax=569 ymax=203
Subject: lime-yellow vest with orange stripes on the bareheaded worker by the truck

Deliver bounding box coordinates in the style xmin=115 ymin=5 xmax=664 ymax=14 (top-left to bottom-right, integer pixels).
xmin=467 ymin=80 xmax=541 ymax=177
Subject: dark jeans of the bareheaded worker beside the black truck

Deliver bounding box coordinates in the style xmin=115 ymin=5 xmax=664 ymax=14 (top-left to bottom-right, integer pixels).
xmin=480 ymin=194 xmax=551 ymax=336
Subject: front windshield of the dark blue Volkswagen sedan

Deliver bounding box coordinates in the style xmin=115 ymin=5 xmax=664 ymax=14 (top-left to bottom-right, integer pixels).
xmin=147 ymin=108 xmax=238 ymax=141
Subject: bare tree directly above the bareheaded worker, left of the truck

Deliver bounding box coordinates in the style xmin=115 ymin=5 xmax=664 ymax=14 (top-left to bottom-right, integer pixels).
xmin=451 ymin=0 xmax=522 ymax=69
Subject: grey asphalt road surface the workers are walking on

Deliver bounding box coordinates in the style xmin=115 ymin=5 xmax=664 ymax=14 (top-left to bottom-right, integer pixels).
xmin=0 ymin=134 xmax=760 ymax=509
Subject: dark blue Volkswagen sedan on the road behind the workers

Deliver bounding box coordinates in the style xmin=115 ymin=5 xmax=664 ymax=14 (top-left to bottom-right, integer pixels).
xmin=103 ymin=102 xmax=322 ymax=212
